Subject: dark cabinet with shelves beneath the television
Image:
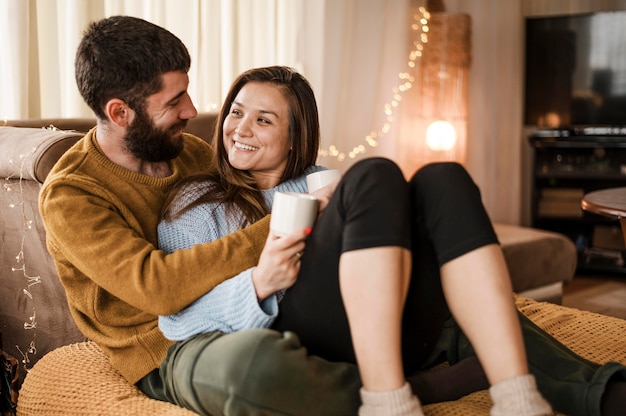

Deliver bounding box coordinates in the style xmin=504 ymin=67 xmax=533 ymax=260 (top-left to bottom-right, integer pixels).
xmin=529 ymin=128 xmax=626 ymax=274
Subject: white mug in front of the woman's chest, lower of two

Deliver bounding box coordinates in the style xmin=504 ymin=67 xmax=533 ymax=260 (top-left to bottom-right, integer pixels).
xmin=270 ymin=192 xmax=319 ymax=237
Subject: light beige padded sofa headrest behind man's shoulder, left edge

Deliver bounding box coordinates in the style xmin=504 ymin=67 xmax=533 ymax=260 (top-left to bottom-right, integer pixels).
xmin=0 ymin=126 xmax=84 ymax=183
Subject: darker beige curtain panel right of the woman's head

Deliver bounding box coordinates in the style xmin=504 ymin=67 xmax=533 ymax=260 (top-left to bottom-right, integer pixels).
xmin=312 ymin=0 xmax=409 ymax=170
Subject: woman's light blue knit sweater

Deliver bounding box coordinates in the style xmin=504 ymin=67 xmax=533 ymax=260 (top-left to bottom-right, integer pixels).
xmin=158 ymin=166 xmax=325 ymax=341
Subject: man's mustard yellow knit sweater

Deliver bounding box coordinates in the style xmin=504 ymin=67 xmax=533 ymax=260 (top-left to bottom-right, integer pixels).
xmin=39 ymin=129 xmax=269 ymax=384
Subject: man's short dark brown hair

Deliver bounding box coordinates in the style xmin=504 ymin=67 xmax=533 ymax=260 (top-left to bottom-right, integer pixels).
xmin=75 ymin=16 xmax=191 ymax=120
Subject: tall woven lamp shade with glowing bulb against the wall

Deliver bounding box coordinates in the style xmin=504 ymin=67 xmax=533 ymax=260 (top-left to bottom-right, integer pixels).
xmin=404 ymin=12 xmax=472 ymax=171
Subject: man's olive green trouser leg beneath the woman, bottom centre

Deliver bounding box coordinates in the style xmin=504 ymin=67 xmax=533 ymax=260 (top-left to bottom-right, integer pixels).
xmin=138 ymin=329 xmax=361 ymax=416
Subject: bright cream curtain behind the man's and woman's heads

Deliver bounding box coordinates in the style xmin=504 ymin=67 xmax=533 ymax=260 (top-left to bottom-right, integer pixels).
xmin=0 ymin=0 xmax=303 ymax=119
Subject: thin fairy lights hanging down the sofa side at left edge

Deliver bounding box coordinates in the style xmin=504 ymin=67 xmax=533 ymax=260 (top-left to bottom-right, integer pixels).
xmin=3 ymin=147 xmax=41 ymax=372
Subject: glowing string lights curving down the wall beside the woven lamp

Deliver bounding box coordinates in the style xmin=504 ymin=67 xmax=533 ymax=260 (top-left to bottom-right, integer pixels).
xmin=319 ymin=7 xmax=430 ymax=162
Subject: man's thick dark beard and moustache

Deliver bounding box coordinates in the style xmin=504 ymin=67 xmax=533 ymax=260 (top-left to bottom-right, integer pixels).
xmin=124 ymin=110 xmax=187 ymax=162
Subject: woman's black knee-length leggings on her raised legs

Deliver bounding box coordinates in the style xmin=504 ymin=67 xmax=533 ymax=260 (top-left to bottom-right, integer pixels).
xmin=273 ymin=158 xmax=497 ymax=373
